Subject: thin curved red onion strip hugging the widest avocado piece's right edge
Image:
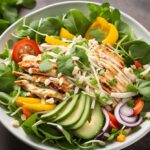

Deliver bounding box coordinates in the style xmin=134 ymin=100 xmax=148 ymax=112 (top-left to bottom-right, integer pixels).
xmin=95 ymin=108 xmax=110 ymax=140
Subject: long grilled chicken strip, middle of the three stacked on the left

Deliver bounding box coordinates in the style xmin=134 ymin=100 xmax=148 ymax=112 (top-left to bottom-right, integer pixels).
xmin=13 ymin=71 xmax=70 ymax=94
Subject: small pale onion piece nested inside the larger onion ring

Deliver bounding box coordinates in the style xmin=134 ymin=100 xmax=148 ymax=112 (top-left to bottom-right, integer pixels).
xmin=120 ymin=104 xmax=134 ymax=117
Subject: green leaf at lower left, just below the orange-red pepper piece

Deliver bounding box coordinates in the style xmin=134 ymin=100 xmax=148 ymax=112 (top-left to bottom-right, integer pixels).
xmin=21 ymin=113 xmax=38 ymax=135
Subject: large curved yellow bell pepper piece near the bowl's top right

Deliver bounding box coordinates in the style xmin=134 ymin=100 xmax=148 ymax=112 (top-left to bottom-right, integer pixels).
xmin=85 ymin=17 xmax=119 ymax=45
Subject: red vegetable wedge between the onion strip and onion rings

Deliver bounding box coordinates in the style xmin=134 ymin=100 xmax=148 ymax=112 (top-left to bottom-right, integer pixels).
xmin=107 ymin=111 xmax=120 ymax=130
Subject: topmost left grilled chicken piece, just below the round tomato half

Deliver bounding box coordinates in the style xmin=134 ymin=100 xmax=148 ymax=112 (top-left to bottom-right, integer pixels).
xmin=18 ymin=54 xmax=57 ymax=77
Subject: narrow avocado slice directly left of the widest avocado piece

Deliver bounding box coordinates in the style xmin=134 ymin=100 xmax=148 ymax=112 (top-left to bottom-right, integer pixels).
xmin=70 ymin=96 xmax=91 ymax=129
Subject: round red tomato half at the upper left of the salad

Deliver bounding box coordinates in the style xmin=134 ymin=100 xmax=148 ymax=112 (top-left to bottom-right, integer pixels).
xmin=12 ymin=39 xmax=41 ymax=63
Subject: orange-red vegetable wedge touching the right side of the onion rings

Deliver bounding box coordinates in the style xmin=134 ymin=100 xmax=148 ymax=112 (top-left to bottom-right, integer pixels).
xmin=133 ymin=98 xmax=144 ymax=116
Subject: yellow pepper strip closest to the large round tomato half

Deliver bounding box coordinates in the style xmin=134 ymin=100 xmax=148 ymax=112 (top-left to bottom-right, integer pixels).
xmin=45 ymin=36 xmax=68 ymax=46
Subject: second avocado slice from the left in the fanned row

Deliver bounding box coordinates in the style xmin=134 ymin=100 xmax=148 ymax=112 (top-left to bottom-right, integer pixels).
xmin=52 ymin=95 xmax=79 ymax=122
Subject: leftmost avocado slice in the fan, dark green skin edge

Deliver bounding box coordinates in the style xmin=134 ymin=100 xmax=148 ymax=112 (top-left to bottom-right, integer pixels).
xmin=41 ymin=99 xmax=69 ymax=121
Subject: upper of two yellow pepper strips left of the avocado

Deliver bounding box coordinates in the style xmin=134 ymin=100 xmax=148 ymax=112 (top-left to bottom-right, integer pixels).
xmin=16 ymin=96 xmax=41 ymax=107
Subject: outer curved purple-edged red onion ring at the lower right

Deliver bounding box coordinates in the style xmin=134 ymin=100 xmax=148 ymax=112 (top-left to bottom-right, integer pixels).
xmin=114 ymin=102 xmax=143 ymax=127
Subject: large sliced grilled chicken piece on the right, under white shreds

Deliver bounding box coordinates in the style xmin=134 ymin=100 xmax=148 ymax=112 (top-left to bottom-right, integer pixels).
xmin=92 ymin=45 xmax=136 ymax=93
